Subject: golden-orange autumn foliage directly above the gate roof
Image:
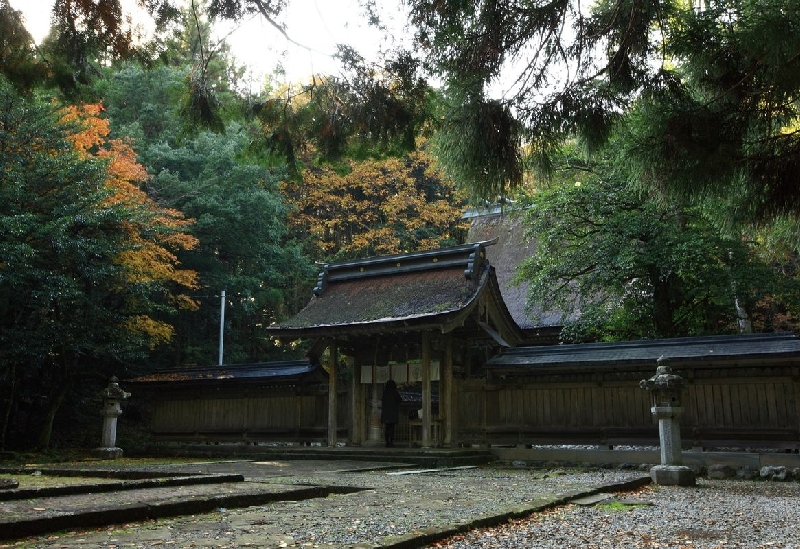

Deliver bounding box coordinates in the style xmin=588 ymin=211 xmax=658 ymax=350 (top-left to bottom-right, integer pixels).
xmin=283 ymin=152 xmax=464 ymax=257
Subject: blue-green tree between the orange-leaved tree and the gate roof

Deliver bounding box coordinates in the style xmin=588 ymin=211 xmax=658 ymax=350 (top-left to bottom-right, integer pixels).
xmin=145 ymin=124 xmax=312 ymax=363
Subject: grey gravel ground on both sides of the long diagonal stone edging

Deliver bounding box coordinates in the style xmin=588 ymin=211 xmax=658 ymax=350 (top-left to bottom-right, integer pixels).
xmin=6 ymin=467 xmax=800 ymax=549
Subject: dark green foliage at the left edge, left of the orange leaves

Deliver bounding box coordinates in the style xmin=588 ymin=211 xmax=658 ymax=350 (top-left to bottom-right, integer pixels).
xmin=0 ymin=77 xmax=123 ymax=362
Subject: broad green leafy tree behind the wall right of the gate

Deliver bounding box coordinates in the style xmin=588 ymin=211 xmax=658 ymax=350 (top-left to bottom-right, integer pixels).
xmin=518 ymin=152 xmax=780 ymax=341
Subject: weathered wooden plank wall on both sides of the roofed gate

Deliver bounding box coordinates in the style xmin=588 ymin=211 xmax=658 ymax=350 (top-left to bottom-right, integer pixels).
xmin=141 ymin=365 xmax=800 ymax=450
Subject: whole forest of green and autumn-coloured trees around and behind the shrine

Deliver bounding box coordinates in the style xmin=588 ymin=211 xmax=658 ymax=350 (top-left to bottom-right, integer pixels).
xmin=0 ymin=0 xmax=800 ymax=450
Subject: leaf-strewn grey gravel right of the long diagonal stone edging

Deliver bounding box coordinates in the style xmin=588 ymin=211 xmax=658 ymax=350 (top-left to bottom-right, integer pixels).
xmin=435 ymin=479 xmax=800 ymax=549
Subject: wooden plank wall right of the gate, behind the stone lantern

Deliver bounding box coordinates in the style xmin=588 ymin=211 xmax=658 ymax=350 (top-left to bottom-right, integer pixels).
xmin=455 ymin=366 xmax=800 ymax=450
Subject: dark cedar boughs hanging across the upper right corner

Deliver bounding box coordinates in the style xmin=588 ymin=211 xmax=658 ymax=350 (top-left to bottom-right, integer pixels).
xmin=406 ymin=0 xmax=800 ymax=219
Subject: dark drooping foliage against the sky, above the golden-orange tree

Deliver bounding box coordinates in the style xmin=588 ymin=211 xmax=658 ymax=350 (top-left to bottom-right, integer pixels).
xmin=254 ymin=46 xmax=432 ymax=172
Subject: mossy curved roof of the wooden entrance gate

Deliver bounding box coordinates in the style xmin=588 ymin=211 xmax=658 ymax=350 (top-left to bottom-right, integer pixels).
xmin=268 ymin=242 xmax=521 ymax=345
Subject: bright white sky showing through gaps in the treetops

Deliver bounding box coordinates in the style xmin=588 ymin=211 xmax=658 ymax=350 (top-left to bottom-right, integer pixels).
xmin=4 ymin=0 xmax=405 ymax=82
